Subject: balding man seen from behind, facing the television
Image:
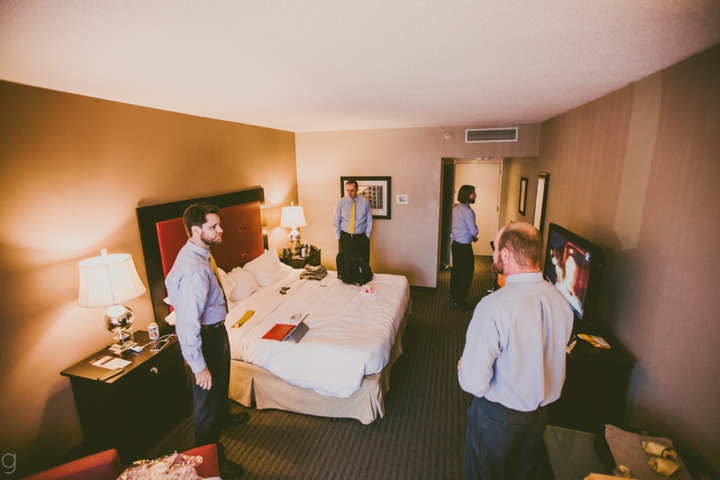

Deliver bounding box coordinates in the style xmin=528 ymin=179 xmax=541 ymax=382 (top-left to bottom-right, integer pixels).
xmin=458 ymin=222 xmax=573 ymax=480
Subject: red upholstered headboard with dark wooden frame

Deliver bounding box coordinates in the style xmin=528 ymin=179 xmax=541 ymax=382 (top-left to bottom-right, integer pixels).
xmin=136 ymin=187 xmax=267 ymax=334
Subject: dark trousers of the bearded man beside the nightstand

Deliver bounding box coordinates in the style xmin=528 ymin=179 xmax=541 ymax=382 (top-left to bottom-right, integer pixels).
xmin=193 ymin=326 xmax=230 ymax=461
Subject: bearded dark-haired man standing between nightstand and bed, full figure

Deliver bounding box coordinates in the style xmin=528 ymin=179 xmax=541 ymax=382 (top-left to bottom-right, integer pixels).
xmin=165 ymin=202 xmax=249 ymax=478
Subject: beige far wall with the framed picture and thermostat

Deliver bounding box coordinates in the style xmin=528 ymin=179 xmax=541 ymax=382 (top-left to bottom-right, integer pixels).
xmin=295 ymin=124 xmax=540 ymax=287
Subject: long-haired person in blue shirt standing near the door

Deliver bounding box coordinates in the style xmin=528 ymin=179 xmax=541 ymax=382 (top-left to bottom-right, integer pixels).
xmin=450 ymin=185 xmax=478 ymax=310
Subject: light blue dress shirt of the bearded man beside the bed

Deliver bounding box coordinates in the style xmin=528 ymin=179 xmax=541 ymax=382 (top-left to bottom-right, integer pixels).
xmin=165 ymin=240 xmax=227 ymax=373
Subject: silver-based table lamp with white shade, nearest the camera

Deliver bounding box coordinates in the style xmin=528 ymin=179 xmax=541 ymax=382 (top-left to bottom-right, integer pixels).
xmin=78 ymin=249 xmax=145 ymax=353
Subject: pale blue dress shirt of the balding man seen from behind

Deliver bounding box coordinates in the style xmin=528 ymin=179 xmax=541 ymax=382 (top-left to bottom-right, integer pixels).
xmin=458 ymin=272 xmax=573 ymax=412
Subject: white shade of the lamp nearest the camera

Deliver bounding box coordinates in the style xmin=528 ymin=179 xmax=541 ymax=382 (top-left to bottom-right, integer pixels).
xmin=78 ymin=250 xmax=145 ymax=308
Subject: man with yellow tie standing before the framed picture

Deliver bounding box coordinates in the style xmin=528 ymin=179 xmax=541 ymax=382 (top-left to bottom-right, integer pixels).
xmin=333 ymin=180 xmax=372 ymax=265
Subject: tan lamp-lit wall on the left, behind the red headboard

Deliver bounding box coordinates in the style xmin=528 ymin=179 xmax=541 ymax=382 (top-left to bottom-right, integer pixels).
xmin=0 ymin=82 xmax=297 ymax=469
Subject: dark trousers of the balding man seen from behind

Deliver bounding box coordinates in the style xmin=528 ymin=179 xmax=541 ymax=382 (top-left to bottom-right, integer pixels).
xmin=464 ymin=396 xmax=547 ymax=480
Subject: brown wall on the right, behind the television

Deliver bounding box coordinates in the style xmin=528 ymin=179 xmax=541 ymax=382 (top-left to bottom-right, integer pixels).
xmin=536 ymin=46 xmax=720 ymax=469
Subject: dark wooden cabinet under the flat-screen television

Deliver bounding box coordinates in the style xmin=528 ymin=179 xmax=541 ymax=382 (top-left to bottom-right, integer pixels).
xmin=548 ymin=328 xmax=633 ymax=433
